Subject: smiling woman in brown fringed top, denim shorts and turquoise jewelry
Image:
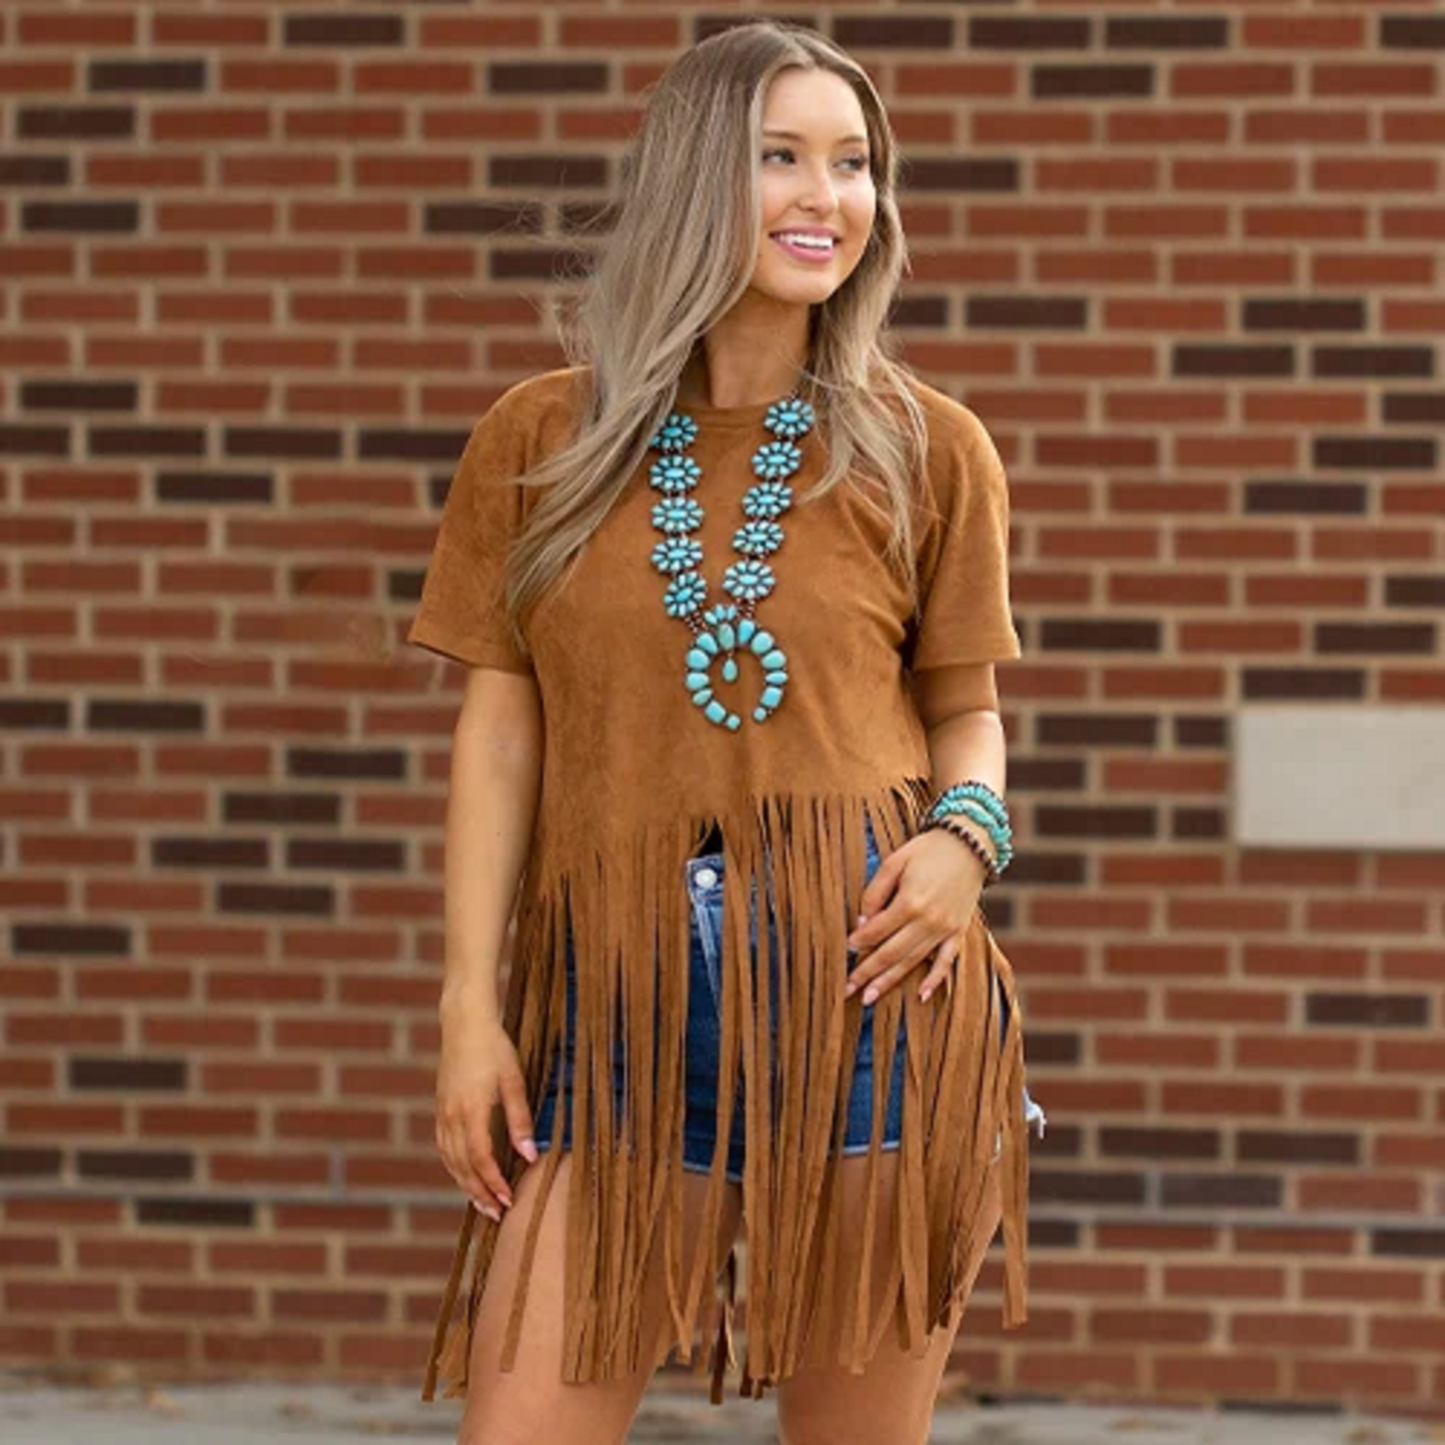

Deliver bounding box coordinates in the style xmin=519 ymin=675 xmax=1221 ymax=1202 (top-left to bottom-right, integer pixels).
xmin=409 ymin=22 xmax=1042 ymax=1445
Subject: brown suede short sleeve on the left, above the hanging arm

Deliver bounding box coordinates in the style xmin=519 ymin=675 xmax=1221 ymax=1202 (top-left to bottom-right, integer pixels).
xmin=406 ymin=396 xmax=536 ymax=676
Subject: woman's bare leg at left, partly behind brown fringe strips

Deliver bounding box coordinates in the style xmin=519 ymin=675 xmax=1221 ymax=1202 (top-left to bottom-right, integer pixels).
xmin=458 ymin=1152 xmax=743 ymax=1445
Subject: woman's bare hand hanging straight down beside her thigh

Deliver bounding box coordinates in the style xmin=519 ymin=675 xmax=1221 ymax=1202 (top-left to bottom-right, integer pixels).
xmin=436 ymin=1004 xmax=538 ymax=1224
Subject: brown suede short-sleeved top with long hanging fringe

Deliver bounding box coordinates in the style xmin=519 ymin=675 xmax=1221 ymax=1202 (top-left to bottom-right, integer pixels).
xmin=407 ymin=368 xmax=1027 ymax=1402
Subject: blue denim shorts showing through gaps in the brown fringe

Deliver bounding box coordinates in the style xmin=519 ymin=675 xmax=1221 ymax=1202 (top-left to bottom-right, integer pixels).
xmin=532 ymin=824 xmax=1009 ymax=1183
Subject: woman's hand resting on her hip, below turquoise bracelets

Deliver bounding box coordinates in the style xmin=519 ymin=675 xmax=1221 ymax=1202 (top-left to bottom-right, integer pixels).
xmin=844 ymin=828 xmax=985 ymax=1004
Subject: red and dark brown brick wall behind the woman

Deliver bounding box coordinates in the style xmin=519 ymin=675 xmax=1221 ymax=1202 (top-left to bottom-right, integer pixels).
xmin=0 ymin=0 xmax=1445 ymax=1410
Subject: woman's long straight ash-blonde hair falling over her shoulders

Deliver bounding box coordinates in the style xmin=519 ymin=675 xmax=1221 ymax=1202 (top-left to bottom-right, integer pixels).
xmin=506 ymin=20 xmax=928 ymax=661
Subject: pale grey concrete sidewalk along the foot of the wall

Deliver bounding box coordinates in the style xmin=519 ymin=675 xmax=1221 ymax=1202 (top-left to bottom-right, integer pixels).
xmin=0 ymin=1371 xmax=1427 ymax=1445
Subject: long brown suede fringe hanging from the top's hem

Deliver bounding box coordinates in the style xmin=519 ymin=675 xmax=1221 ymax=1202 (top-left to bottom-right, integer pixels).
xmin=422 ymin=777 xmax=1029 ymax=1403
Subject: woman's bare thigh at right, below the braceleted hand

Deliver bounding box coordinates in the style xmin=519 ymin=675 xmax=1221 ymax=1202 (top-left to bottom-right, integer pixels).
xmin=776 ymin=1153 xmax=1003 ymax=1445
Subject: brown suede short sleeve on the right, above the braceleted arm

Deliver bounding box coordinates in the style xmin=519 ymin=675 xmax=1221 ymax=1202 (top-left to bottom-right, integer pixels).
xmin=905 ymin=402 xmax=1023 ymax=672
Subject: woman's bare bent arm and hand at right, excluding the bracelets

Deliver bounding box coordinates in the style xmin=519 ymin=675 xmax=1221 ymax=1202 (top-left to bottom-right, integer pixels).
xmin=844 ymin=662 xmax=1007 ymax=1004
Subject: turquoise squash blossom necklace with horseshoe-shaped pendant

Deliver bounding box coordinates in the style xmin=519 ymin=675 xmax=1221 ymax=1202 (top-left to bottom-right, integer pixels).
xmin=647 ymin=393 xmax=815 ymax=733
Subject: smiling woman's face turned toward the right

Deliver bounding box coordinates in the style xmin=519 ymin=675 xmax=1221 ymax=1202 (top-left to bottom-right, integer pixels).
xmin=751 ymin=68 xmax=877 ymax=305
